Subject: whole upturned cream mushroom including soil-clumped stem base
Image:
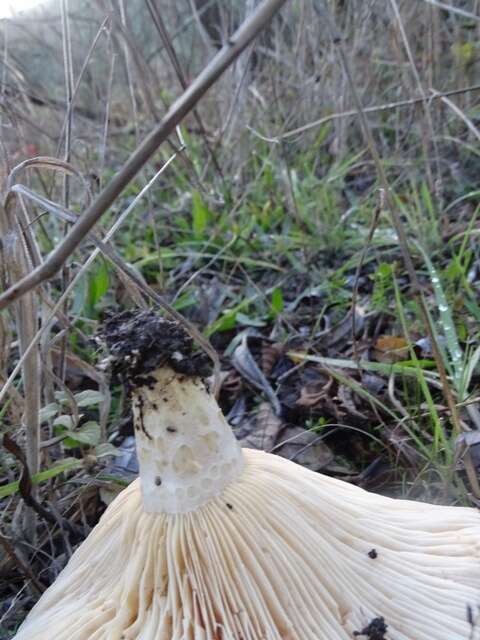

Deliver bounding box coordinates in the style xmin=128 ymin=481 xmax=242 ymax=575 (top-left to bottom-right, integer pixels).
xmin=15 ymin=311 xmax=480 ymax=640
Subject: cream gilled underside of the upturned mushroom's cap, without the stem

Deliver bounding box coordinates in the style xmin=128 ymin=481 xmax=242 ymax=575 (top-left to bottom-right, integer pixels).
xmin=15 ymin=449 xmax=480 ymax=640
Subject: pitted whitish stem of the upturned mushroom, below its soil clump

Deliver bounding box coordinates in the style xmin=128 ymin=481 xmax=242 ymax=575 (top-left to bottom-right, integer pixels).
xmin=133 ymin=368 xmax=244 ymax=513
